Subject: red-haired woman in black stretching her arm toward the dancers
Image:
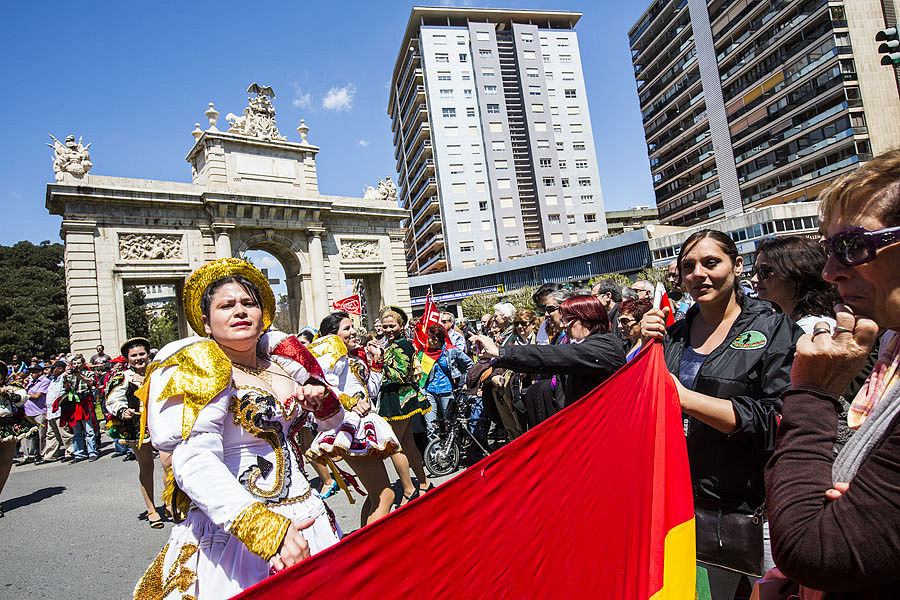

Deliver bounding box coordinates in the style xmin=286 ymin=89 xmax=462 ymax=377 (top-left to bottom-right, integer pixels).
xmin=472 ymin=295 xmax=625 ymax=406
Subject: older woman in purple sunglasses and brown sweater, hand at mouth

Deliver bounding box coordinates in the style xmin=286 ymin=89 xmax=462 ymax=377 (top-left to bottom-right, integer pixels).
xmin=766 ymin=150 xmax=900 ymax=600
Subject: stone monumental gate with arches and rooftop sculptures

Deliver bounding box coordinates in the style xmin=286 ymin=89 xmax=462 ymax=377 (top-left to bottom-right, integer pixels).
xmin=47 ymin=84 xmax=409 ymax=352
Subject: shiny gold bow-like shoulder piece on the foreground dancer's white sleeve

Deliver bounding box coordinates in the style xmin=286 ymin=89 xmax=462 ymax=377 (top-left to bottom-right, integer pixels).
xmin=135 ymin=340 xmax=232 ymax=440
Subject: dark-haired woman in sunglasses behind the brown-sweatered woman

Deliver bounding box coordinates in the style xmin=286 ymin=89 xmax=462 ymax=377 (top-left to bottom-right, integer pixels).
xmin=752 ymin=235 xmax=840 ymax=333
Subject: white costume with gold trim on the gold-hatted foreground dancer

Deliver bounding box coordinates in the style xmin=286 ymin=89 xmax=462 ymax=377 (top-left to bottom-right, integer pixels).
xmin=134 ymin=332 xmax=343 ymax=600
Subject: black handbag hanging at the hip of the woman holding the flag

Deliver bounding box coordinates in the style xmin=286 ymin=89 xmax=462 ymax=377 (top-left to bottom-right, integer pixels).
xmin=694 ymin=498 xmax=766 ymax=577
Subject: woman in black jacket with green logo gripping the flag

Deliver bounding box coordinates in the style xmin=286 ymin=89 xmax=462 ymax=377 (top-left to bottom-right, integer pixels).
xmin=641 ymin=229 xmax=802 ymax=600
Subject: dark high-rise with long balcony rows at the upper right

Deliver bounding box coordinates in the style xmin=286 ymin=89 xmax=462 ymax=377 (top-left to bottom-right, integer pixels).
xmin=628 ymin=0 xmax=900 ymax=225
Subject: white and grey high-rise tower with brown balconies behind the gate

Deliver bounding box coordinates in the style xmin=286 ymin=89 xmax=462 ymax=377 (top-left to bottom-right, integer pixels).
xmin=388 ymin=7 xmax=606 ymax=275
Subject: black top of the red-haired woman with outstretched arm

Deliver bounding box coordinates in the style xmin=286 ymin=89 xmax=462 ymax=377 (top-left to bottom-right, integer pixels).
xmin=496 ymin=333 xmax=625 ymax=406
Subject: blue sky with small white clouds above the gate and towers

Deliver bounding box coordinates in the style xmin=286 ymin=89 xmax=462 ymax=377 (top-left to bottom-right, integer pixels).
xmin=0 ymin=0 xmax=653 ymax=258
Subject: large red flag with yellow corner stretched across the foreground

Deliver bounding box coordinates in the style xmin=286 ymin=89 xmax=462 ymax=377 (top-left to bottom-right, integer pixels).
xmin=236 ymin=343 xmax=696 ymax=600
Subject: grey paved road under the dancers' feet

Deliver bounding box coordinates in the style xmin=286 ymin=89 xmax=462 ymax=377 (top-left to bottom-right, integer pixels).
xmin=0 ymin=444 xmax=450 ymax=600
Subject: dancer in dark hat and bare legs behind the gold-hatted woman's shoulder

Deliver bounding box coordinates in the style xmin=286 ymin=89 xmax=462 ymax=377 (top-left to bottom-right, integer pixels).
xmin=106 ymin=337 xmax=163 ymax=529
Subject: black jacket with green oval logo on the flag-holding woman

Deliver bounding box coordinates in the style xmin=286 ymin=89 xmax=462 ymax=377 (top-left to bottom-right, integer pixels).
xmin=663 ymin=298 xmax=800 ymax=513
